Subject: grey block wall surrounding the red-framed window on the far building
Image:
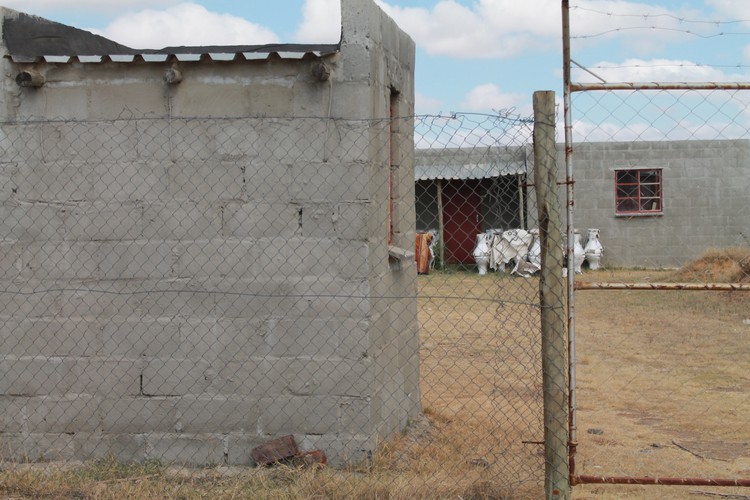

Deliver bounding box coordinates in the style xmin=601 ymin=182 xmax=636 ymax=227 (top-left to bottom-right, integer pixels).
xmin=558 ymin=140 xmax=750 ymax=268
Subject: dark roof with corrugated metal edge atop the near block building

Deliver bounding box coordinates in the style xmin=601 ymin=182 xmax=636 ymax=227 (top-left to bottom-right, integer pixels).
xmin=2 ymin=9 xmax=340 ymax=64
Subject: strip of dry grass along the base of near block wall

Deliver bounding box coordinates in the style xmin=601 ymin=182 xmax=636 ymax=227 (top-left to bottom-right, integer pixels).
xmin=0 ymin=460 xmax=504 ymax=500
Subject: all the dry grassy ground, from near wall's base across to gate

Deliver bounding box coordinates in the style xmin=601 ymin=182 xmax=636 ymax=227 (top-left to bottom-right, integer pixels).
xmin=0 ymin=252 xmax=750 ymax=499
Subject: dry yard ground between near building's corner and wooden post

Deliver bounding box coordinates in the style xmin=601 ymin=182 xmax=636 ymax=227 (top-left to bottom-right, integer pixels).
xmin=414 ymin=272 xmax=544 ymax=498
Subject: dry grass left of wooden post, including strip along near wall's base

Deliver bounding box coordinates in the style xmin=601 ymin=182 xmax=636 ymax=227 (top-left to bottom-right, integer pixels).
xmin=0 ymin=272 xmax=543 ymax=499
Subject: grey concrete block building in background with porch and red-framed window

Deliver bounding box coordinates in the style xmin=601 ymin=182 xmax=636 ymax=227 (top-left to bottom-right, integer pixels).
xmin=415 ymin=139 xmax=750 ymax=268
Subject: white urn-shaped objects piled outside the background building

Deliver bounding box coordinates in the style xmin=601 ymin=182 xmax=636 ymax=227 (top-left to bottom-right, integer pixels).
xmin=473 ymin=228 xmax=604 ymax=276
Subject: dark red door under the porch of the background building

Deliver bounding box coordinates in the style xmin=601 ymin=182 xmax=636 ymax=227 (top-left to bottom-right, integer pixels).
xmin=443 ymin=180 xmax=483 ymax=264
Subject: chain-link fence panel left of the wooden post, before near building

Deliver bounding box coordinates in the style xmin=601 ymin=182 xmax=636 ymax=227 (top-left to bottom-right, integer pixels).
xmin=0 ymin=111 xmax=566 ymax=497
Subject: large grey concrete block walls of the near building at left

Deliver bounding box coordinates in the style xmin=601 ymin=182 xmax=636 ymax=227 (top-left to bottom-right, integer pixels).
xmin=0 ymin=0 xmax=420 ymax=464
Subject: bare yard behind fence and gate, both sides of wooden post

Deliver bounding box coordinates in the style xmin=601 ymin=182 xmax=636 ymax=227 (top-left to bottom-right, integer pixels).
xmin=420 ymin=250 xmax=750 ymax=499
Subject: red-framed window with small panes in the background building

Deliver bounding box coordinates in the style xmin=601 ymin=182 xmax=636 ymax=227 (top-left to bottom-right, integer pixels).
xmin=615 ymin=169 xmax=662 ymax=215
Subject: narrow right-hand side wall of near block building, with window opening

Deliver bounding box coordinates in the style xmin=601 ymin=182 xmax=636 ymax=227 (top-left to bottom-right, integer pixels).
xmin=346 ymin=0 xmax=421 ymax=439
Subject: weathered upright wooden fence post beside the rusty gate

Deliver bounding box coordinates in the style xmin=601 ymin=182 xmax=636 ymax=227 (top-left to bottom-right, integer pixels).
xmin=534 ymin=91 xmax=570 ymax=499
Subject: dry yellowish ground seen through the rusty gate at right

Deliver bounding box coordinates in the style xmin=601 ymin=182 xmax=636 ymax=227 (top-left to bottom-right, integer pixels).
xmin=574 ymin=260 xmax=750 ymax=498
